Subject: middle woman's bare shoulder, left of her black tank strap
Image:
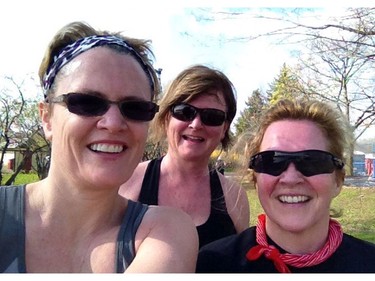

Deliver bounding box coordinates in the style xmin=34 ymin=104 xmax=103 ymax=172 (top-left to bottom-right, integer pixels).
xmin=119 ymin=160 xmax=150 ymax=197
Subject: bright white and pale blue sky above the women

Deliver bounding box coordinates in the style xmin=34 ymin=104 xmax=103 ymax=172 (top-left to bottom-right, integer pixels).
xmin=0 ymin=0 xmax=375 ymax=139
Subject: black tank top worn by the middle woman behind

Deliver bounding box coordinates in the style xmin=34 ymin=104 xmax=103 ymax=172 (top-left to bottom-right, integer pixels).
xmin=138 ymin=157 xmax=237 ymax=247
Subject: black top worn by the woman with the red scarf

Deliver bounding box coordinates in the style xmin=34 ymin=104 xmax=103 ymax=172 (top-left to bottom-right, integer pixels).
xmin=196 ymin=223 xmax=375 ymax=273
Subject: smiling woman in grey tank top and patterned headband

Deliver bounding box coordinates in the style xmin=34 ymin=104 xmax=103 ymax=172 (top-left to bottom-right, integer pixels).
xmin=0 ymin=22 xmax=198 ymax=273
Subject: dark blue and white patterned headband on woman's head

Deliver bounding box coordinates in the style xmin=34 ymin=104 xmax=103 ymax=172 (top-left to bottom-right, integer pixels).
xmin=43 ymin=35 xmax=154 ymax=98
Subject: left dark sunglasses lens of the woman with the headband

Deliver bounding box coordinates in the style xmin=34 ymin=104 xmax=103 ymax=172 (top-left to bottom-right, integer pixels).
xmin=66 ymin=94 xmax=109 ymax=116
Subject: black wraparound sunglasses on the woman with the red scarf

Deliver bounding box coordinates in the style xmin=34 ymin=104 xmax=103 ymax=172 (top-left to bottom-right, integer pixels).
xmin=249 ymin=150 xmax=344 ymax=177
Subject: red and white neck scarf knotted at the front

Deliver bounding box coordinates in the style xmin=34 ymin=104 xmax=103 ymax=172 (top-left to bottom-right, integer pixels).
xmin=246 ymin=214 xmax=343 ymax=273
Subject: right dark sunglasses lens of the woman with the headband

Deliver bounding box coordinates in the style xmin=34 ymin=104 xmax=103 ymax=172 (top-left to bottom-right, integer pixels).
xmin=120 ymin=101 xmax=158 ymax=121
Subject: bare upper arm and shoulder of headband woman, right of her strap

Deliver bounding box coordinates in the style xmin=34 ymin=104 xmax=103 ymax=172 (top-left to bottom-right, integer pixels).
xmin=126 ymin=203 xmax=198 ymax=273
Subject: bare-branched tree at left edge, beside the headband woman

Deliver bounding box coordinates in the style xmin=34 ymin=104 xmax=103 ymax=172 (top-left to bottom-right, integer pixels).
xmin=0 ymin=77 xmax=50 ymax=185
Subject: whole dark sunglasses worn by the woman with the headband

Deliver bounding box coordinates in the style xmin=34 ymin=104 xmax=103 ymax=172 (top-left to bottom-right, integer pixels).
xmin=47 ymin=93 xmax=159 ymax=121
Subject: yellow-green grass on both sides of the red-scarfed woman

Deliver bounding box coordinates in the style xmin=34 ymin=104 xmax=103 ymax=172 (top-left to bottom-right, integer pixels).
xmin=247 ymin=187 xmax=375 ymax=243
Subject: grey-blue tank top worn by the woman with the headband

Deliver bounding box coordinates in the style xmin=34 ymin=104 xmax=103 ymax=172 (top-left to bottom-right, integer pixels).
xmin=0 ymin=185 xmax=148 ymax=273
